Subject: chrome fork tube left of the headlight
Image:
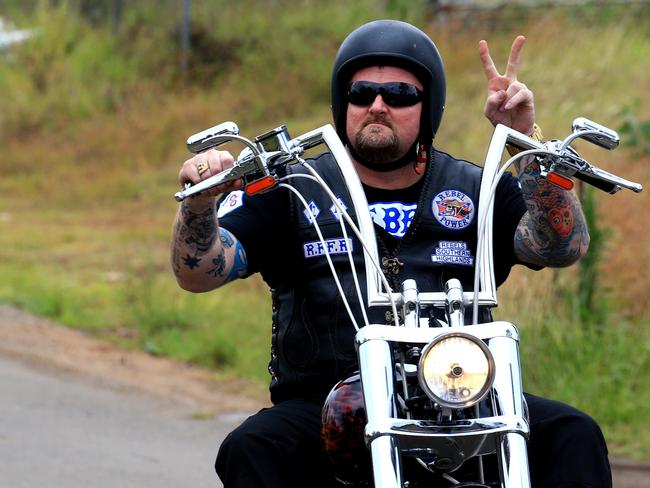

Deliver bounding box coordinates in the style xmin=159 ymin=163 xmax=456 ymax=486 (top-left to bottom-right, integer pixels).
xmin=359 ymin=340 xmax=402 ymax=488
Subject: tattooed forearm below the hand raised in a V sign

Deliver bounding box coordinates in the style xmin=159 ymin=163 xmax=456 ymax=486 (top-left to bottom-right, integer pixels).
xmin=514 ymin=157 xmax=589 ymax=267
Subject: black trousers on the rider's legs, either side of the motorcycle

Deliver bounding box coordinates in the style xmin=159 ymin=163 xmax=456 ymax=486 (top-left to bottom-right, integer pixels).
xmin=215 ymin=394 xmax=612 ymax=488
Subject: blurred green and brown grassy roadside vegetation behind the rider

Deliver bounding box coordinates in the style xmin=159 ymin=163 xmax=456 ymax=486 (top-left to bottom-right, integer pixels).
xmin=0 ymin=0 xmax=650 ymax=459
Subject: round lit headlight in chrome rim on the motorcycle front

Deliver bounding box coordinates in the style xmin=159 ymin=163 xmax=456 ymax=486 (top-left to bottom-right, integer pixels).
xmin=418 ymin=332 xmax=494 ymax=408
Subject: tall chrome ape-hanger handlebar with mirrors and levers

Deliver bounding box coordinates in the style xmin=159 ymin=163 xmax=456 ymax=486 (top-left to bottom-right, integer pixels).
xmin=175 ymin=119 xmax=643 ymax=316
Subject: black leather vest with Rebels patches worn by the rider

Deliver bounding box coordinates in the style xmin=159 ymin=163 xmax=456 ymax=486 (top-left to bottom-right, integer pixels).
xmin=269 ymin=151 xmax=498 ymax=403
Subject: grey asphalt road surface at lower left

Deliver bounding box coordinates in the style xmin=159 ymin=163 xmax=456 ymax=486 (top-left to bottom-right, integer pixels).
xmin=0 ymin=356 xmax=247 ymax=488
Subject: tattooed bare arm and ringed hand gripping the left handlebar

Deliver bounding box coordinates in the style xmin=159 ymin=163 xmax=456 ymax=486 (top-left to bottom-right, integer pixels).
xmin=171 ymin=150 xmax=248 ymax=292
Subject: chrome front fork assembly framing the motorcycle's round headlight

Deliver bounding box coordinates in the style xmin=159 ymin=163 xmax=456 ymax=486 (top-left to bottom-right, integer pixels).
xmin=356 ymin=287 xmax=530 ymax=488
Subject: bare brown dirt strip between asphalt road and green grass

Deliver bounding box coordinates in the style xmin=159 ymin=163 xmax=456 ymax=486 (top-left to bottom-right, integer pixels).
xmin=0 ymin=305 xmax=268 ymax=415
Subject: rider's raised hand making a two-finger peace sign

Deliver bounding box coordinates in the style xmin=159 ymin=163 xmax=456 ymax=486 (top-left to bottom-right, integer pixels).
xmin=478 ymin=36 xmax=535 ymax=135
